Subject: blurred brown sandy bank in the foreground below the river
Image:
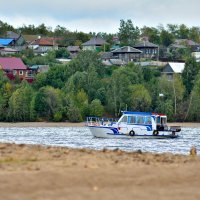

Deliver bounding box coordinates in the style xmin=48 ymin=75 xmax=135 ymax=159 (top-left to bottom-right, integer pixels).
xmin=0 ymin=144 xmax=200 ymax=200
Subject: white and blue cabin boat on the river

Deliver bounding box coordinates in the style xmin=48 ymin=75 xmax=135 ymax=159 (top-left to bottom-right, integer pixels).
xmin=86 ymin=111 xmax=181 ymax=139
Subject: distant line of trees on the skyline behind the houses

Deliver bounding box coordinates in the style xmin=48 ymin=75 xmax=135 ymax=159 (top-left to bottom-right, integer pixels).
xmin=0 ymin=19 xmax=200 ymax=47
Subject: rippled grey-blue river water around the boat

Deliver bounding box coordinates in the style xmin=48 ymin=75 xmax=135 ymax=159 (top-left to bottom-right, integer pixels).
xmin=0 ymin=127 xmax=200 ymax=155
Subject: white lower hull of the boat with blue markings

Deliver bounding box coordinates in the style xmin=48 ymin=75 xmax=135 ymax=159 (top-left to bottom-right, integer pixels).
xmin=88 ymin=126 xmax=179 ymax=139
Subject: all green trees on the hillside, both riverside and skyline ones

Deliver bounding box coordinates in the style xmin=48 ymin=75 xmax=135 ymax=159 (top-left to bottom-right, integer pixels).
xmin=0 ymin=20 xmax=200 ymax=122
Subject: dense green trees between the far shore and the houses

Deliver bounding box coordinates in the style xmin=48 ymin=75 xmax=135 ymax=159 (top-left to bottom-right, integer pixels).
xmin=0 ymin=51 xmax=200 ymax=122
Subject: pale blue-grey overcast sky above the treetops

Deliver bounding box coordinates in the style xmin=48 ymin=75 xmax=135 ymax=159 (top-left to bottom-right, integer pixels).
xmin=0 ymin=0 xmax=200 ymax=33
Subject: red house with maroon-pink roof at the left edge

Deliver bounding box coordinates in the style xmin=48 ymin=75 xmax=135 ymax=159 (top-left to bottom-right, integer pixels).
xmin=0 ymin=57 xmax=33 ymax=82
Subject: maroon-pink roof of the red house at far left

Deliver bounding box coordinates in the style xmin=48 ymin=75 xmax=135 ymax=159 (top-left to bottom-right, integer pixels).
xmin=0 ymin=57 xmax=27 ymax=70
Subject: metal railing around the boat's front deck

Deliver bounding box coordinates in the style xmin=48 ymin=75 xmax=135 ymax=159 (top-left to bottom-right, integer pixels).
xmin=86 ymin=117 xmax=118 ymax=126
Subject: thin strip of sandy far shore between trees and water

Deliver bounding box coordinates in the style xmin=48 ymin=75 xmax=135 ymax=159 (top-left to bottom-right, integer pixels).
xmin=0 ymin=122 xmax=200 ymax=128
